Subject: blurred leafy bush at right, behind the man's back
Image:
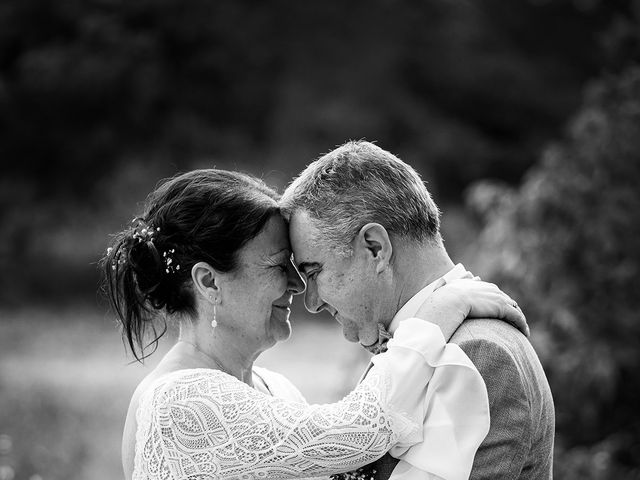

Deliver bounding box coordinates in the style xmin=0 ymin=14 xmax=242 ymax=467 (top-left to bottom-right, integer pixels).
xmin=469 ymin=66 xmax=640 ymax=479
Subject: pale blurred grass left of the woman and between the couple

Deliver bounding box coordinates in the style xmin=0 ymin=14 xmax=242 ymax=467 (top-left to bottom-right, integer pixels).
xmin=0 ymin=309 xmax=368 ymax=480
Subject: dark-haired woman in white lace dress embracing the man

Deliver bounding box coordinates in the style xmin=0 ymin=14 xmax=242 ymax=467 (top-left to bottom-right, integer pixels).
xmin=103 ymin=170 xmax=519 ymax=479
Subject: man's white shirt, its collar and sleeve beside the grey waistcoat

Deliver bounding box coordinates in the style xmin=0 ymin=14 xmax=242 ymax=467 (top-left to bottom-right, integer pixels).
xmin=372 ymin=264 xmax=490 ymax=480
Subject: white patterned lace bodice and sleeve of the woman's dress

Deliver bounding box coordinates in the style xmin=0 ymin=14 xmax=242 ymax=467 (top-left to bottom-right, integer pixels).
xmin=133 ymin=369 xmax=404 ymax=480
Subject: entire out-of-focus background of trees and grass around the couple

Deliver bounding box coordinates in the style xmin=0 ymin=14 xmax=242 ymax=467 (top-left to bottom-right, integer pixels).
xmin=0 ymin=0 xmax=640 ymax=480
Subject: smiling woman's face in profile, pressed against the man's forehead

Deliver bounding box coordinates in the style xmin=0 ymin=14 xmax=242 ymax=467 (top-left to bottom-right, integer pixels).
xmin=217 ymin=215 xmax=304 ymax=353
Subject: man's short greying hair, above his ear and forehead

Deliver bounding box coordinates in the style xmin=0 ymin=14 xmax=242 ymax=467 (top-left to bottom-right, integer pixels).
xmin=280 ymin=141 xmax=441 ymax=253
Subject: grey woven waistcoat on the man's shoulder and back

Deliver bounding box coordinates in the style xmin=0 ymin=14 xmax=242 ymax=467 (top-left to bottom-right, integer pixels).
xmin=450 ymin=319 xmax=555 ymax=479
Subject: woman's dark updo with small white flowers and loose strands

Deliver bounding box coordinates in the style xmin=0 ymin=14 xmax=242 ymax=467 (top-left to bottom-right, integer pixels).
xmin=101 ymin=169 xmax=279 ymax=361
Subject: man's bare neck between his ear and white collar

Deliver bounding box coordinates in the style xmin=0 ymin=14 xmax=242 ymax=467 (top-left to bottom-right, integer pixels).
xmin=394 ymin=242 xmax=455 ymax=315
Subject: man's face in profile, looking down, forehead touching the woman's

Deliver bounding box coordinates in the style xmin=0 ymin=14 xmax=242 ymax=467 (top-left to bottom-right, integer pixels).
xmin=289 ymin=211 xmax=391 ymax=347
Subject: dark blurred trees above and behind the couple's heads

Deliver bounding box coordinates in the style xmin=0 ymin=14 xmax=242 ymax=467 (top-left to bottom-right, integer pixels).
xmin=0 ymin=0 xmax=640 ymax=304
